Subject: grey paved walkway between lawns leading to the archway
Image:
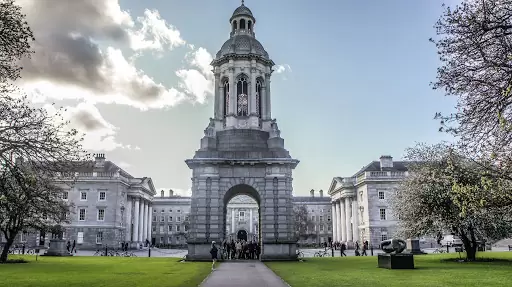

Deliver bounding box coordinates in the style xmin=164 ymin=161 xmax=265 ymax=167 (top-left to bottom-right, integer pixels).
xmin=201 ymin=261 xmax=289 ymax=287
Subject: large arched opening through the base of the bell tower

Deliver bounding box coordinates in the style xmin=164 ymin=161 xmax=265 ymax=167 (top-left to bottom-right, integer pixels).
xmin=223 ymin=184 xmax=261 ymax=259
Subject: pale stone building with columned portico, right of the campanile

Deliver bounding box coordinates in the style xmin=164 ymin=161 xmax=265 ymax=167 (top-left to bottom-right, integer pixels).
xmin=328 ymin=156 xmax=408 ymax=249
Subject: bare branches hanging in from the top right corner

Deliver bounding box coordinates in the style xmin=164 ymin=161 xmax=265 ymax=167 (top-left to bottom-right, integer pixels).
xmin=430 ymin=0 xmax=512 ymax=173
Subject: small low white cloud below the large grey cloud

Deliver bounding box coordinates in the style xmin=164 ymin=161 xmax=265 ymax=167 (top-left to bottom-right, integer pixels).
xmin=44 ymin=103 xmax=135 ymax=151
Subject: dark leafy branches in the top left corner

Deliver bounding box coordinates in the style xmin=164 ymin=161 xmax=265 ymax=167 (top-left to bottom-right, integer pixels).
xmin=0 ymin=0 xmax=35 ymax=84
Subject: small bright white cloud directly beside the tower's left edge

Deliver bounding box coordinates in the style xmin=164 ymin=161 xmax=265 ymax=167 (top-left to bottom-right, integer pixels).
xmin=176 ymin=45 xmax=214 ymax=103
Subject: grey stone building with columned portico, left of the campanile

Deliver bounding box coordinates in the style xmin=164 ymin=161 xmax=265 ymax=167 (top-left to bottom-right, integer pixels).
xmin=2 ymin=154 xmax=155 ymax=250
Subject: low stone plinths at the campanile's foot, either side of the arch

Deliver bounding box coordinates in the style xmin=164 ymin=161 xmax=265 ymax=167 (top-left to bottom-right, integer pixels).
xmin=186 ymin=242 xmax=297 ymax=261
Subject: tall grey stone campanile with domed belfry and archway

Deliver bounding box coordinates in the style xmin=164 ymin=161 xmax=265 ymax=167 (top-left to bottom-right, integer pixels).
xmin=186 ymin=1 xmax=299 ymax=260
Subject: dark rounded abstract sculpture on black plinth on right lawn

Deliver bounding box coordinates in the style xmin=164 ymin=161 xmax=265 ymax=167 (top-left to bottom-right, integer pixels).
xmin=378 ymin=238 xmax=414 ymax=269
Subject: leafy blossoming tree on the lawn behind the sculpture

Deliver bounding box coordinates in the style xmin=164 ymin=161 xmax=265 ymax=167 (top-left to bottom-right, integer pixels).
xmin=391 ymin=144 xmax=512 ymax=261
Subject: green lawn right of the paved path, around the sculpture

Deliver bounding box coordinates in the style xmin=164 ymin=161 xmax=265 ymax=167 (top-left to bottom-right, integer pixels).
xmin=266 ymin=252 xmax=512 ymax=287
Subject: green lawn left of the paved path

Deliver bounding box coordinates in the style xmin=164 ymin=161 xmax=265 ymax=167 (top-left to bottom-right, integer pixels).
xmin=0 ymin=256 xmax=211 ymax=287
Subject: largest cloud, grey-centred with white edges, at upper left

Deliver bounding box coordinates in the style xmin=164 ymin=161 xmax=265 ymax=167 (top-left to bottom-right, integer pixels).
xmin=20 ymin=0 xmax=191 ymax=110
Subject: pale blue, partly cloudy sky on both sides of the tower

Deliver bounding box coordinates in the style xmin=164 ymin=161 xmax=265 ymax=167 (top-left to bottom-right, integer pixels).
xmin=18 ymin=0 xmax=455 ymax=195
